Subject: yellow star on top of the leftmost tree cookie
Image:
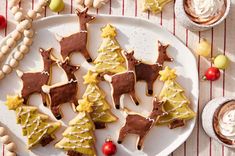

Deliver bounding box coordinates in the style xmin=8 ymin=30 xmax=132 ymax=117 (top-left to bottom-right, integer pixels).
xmin=6 ymin=95 xmax=24 ymax=110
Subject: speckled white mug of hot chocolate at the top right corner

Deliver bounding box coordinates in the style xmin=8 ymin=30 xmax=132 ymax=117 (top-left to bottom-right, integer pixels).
xmin=175 ymin=0 xmax=231 ymax=31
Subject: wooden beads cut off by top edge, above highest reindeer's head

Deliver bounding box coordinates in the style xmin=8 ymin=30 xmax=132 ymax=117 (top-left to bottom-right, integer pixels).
xmin=76 ymin=0 xmax=109 ymax=9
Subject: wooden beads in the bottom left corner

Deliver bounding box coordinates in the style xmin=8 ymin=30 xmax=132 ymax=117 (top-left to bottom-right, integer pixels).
xmin=0 ymin=124 xmax=16 ymax=156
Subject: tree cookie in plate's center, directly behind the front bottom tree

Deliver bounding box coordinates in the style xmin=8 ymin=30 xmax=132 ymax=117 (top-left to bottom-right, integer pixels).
xmin=77 ymin=71 xmax=117 ymax=129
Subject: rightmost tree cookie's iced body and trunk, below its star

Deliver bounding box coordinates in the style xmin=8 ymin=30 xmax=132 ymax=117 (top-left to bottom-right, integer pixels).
xmin=158 ymin=80 xmax=196 ymax=124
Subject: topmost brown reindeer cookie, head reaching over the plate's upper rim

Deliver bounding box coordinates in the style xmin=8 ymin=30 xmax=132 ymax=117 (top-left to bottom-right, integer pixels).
xmin=57 ymin=8 xmax=95 ymax=62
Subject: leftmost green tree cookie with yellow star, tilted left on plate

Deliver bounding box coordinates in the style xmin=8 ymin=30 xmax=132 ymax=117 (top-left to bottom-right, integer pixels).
xmin=6 ymin=96 xmax=60 ymax=148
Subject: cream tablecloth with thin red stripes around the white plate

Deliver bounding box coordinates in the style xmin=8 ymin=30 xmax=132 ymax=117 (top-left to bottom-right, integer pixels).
xmin=0 ymin=0 xmax=235 ymax=156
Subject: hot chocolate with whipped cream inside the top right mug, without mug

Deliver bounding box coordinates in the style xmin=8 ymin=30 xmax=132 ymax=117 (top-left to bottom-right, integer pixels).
xmin=184 ymin=0 xmax=226 ymax=25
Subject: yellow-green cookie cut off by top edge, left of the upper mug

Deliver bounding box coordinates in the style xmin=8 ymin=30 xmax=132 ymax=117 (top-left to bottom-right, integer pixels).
xmin=143 ymin=0 xmax=172 ymax=13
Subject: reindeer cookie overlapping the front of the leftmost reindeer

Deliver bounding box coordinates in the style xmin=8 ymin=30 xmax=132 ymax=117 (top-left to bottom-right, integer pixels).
xmin=42 ymin=58 xmax=80 ymax=120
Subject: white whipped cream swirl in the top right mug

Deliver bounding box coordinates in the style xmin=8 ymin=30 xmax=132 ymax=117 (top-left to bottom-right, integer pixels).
xmin=191 ymin=0 xmax=225 ymax=18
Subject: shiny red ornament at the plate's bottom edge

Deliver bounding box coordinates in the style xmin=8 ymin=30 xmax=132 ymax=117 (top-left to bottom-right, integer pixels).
xmin=102 ymin=139 xmax=117 ymax=156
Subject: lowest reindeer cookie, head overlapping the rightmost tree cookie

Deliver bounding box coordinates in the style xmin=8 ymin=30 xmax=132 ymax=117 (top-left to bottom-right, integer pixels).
xmin=118 ymin=97 xmax=165 ymax=150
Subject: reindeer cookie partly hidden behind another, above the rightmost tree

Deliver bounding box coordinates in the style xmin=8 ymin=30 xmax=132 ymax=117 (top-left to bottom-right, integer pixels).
xmin=135 ymin=41 xmax=173 ymax=95
